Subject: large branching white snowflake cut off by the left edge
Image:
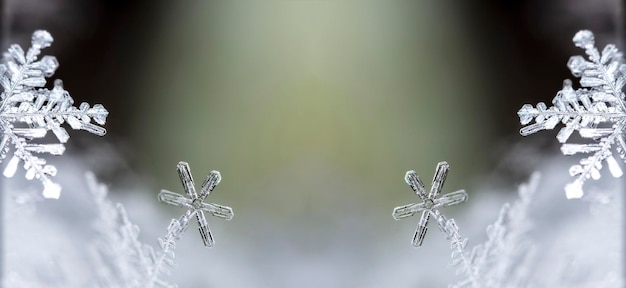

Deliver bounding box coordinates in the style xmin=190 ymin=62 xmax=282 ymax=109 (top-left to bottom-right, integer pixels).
xmin=0 ymin=30 xmax=108 ymax=198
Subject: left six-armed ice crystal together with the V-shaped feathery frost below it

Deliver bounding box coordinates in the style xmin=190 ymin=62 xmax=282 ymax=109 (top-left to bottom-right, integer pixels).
xmin=58 ymin=162 xmax=233 ymax=288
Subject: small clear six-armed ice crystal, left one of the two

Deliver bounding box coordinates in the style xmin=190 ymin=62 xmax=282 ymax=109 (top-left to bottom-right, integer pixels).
xmin=159 ymin=161 xmax=233 ymax=247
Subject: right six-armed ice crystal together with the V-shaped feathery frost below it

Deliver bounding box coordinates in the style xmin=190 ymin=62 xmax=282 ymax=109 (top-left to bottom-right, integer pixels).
xmin=393 ymin=168 xmax=540 ymax=288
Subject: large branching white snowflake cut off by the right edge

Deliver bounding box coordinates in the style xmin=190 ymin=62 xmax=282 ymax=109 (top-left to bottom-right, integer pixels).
xmin=517 ymin=30 xmax=626 ymax=199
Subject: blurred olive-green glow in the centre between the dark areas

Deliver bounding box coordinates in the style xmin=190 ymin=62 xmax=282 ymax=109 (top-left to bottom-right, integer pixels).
xmin=132 ymin=1 xmax=493 ymax=218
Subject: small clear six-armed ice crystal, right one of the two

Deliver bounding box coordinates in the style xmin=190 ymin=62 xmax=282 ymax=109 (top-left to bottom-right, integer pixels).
xmin=392 ymin=162 xmax=468 ymax=247
